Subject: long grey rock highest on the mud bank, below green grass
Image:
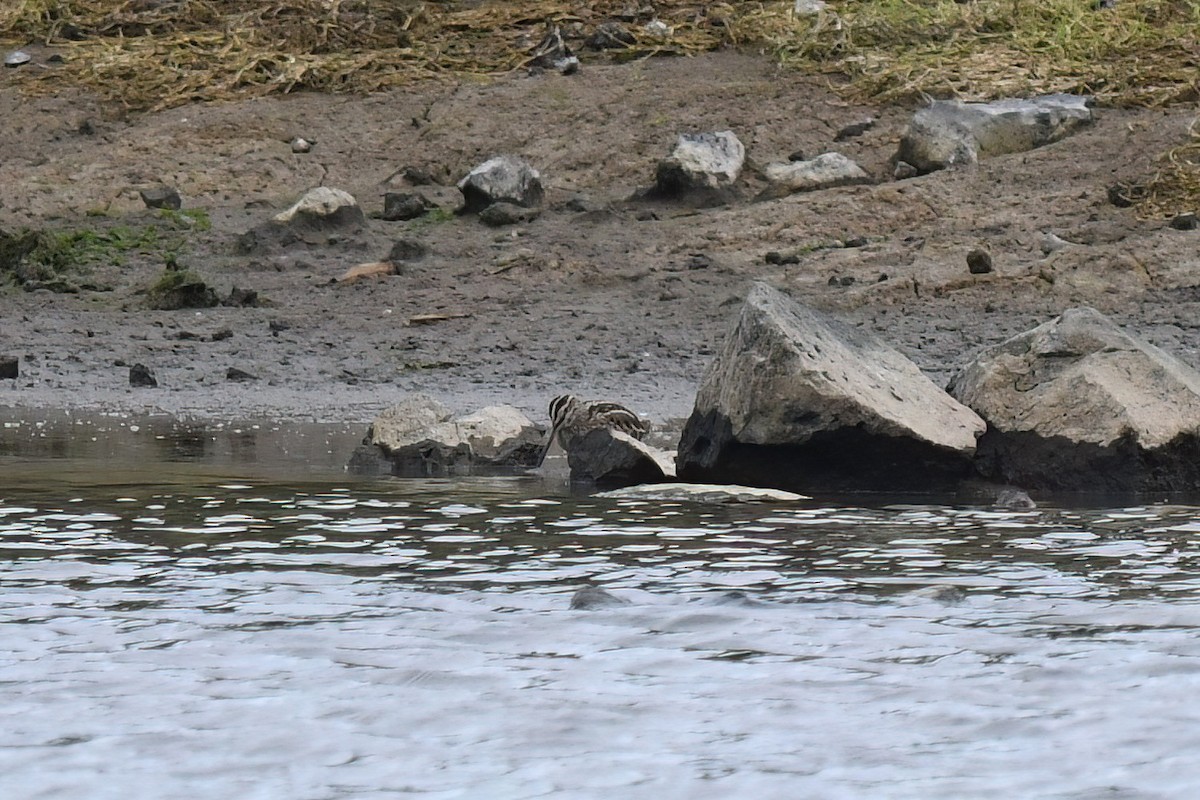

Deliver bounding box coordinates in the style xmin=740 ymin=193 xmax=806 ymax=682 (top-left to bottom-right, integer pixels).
xmin=895 ymin=95 xmax=1093 ymax=174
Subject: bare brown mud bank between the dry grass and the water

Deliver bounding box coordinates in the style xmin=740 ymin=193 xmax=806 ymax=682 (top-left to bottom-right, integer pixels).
xmin=0 ymin=52 xmax=1200 ymax=448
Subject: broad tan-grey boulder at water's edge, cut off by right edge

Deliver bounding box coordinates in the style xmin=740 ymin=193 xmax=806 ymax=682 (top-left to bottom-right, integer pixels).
xmin=949 ymin=308 xmax=1200 ymax=492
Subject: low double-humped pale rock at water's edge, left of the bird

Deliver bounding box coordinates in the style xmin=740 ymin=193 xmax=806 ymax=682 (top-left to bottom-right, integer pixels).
xmin=350 ymin=395 xmax=542 ymax=477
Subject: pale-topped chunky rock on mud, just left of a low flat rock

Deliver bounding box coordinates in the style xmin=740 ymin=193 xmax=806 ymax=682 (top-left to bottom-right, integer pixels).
xmin=652 ymin=131 xmax=746 ymax=200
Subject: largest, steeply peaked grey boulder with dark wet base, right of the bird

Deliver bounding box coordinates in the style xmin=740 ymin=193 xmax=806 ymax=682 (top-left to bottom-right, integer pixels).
xmin=678 ymin=283 xmax=984 ymax=492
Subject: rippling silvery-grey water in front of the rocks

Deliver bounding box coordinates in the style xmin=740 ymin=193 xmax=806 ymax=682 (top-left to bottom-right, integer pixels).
xmin=0 ymin=448 xmax=1200 ymax=800
